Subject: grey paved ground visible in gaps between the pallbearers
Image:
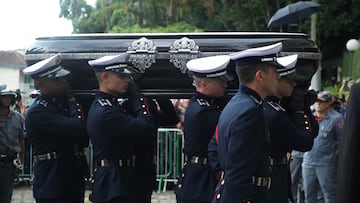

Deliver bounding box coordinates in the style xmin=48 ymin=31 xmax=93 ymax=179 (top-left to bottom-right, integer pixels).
xmin=11 ymin=186 xmax=176 ymax=203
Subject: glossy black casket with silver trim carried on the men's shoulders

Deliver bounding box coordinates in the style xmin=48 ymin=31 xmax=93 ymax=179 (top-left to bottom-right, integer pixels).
xmin=25 ymin=32 xmax=321 ymax=105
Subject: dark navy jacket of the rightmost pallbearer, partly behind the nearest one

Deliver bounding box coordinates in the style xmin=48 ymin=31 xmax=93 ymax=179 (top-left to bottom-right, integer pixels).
xmin=264 ymin=96 xmax=313 ymax=203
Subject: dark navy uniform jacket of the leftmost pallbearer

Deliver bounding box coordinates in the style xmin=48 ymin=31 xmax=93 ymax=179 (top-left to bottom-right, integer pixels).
xmin=25 ymin=95 xmax=88 ymax=199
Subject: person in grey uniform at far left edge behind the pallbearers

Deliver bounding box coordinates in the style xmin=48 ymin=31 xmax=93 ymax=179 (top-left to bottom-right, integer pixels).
xmin=0 ymin=86 xmax=24 ymax=203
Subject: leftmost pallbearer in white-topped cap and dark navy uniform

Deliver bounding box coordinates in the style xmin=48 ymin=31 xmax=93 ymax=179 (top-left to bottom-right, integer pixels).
xmin=23 ymin=54 xmax=88 ymax=203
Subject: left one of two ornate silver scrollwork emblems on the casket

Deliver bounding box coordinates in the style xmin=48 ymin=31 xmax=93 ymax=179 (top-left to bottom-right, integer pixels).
xmin=127 ymin=37 xmax=156 ymax=73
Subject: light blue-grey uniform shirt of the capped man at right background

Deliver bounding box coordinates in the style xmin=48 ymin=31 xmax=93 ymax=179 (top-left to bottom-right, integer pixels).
xmin=303 ymin=110 xmax=344 ymax=166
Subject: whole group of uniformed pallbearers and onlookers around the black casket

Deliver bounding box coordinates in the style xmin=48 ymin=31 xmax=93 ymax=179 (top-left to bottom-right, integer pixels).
xmin=0 ymin=43 xmax=355 ymax=203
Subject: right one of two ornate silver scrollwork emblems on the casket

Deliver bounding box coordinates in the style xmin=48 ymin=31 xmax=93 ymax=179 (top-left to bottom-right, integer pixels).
xmin=169 ymin=37 xmax=200 ymax=73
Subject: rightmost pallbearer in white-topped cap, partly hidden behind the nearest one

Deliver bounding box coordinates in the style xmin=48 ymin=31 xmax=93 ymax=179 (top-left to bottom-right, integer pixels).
xmin=264 ymin=55 xmax=317 ymax=203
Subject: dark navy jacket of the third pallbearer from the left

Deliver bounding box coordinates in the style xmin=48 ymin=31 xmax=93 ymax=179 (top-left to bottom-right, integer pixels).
xmin=175 ymin=92 xmax=226 ymax=201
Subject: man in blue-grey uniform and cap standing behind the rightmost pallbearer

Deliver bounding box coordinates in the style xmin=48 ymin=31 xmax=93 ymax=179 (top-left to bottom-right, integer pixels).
xmin=302 ymin=91 xmax=344 ymax=203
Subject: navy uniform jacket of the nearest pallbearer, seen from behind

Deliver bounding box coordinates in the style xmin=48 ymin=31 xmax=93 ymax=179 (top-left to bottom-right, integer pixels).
xmin=215 ymin=85 xmax=270 ymax=203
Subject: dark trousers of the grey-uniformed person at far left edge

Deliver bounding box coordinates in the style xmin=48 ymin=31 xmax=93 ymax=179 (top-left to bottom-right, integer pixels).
xmin=0 ymin=162 xmax=15 ymax=203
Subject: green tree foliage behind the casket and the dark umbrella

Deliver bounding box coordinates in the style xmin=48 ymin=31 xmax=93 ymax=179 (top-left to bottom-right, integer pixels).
xmin=60 ymin=0 xmax=360 ymax=56
